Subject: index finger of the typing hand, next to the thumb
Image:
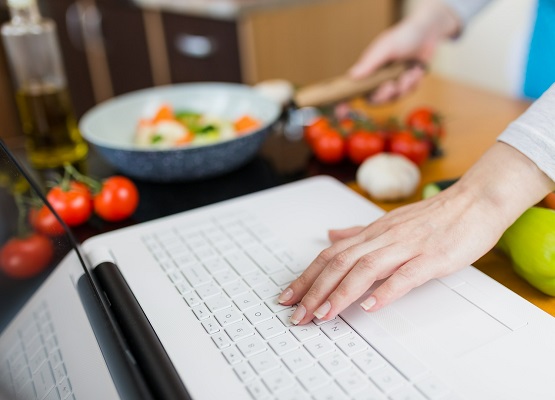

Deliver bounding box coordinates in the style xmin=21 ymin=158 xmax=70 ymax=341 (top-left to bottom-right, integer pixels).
xmin=278 ymin=235 xmax=364 ymax=305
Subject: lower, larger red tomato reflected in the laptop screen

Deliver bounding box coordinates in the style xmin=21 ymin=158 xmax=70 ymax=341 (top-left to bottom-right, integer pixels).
xmin=0 ymin=233 xmax=54 ymax=279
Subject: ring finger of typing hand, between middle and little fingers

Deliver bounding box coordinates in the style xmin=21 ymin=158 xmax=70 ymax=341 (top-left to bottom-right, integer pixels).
xmin=314 ymin=246 xmax=409 ymax=320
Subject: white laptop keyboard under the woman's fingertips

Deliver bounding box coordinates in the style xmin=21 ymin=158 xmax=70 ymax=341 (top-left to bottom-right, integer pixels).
xmin=142 ymin=215 xmax=452 ymax=400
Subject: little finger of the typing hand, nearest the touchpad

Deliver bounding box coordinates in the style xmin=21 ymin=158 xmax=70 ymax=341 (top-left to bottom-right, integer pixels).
xmin=360 ymin=256 xmax=435 ymax=311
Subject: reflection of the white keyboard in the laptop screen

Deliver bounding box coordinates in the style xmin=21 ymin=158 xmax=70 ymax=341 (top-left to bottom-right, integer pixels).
xmin=0 ymin=303 xmax=75 ymax=400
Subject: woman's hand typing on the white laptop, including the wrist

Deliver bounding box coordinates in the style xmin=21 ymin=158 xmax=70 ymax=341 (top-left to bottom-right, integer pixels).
xmin=279 ymin=142 xmax=555 ymax=324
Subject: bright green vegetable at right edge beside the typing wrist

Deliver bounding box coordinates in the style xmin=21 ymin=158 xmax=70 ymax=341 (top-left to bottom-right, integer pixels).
xmin=498 ymin=207 xmax=555 ymax=296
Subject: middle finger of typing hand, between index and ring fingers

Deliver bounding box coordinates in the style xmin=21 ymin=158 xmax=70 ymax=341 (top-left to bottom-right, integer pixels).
xmin=291 ymin=239 xmax=390 ymax=323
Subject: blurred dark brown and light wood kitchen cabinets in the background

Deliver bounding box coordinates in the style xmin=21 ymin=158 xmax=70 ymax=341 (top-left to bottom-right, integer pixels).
xmin=0 ymin=0 xmax=400 ymax=143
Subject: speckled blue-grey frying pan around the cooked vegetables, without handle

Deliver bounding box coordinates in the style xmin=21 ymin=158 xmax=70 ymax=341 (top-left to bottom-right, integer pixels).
xmin=79 ymin=83 xmax=280 ymax=182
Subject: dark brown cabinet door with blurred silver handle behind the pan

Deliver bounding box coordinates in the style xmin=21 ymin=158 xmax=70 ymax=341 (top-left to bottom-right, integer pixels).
xmin=163 ymin=13 xmax=241 ymax=82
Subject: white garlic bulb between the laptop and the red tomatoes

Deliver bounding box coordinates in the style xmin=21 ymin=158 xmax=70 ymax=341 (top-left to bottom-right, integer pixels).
xmin=356 ymin=153 xmax=420 ymax=201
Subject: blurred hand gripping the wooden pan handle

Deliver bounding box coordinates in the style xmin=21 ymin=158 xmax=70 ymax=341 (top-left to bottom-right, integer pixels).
xmin=349 ymin=2 xmax=460 ymax=103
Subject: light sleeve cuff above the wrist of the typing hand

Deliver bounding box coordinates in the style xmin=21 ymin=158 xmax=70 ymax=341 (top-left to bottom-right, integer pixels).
xmin=497 ymin=84 xmax=555 ymax=181
